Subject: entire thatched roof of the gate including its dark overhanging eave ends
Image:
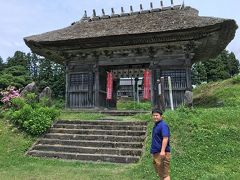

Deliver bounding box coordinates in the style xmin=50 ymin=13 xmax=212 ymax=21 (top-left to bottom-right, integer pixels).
xmin=24 ymin=7 xmax=237 ymax=64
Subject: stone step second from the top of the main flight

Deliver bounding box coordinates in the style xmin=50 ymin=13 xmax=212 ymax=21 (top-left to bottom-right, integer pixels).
xmin=53 ymin=123 xmax=147 ymax=131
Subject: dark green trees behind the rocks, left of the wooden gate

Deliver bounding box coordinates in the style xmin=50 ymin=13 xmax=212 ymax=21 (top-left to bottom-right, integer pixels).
xmin=0 ymin=51 xmax=65 ymax=97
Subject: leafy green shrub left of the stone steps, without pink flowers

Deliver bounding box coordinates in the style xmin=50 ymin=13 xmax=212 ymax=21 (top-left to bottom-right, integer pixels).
xmin=5 ymin=93 xmax=60 ymax=135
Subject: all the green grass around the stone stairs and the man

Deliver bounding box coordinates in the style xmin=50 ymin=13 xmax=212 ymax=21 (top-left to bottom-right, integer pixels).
xmin=0 ymin=76 xmax=240 ymax=180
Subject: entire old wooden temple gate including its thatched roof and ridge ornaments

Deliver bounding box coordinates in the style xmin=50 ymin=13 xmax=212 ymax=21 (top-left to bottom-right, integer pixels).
xmin=24 ymin=5 xmax=237 ymax=108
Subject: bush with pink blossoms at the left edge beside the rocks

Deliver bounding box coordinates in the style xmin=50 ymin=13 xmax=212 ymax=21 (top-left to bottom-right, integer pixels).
xmin=0 ymin=86 xmax=20 ymax=107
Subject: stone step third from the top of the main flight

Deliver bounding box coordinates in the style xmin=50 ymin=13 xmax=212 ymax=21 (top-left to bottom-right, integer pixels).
xmin=49 ymin=128 xmax=145 ymax=136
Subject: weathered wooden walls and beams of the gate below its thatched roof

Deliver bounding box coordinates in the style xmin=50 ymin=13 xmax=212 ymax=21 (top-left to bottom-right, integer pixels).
xmin=66 ymin=43 xmax=191 ymax=108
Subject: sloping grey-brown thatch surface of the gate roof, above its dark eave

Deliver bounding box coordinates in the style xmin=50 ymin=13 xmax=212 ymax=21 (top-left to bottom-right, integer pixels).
xmin=24 ymin=7 xmax=231 ymax=42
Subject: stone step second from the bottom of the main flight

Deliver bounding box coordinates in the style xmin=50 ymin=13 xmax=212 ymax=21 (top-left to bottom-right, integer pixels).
xmin=30 ymin=145 xmax=142 ymax=156
